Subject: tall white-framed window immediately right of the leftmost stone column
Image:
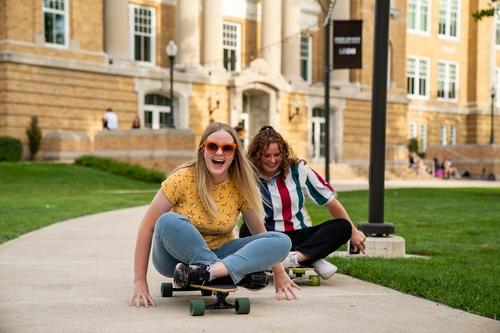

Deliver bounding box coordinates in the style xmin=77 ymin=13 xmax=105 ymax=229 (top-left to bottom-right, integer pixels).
xmin=129 ymin=5 xmax=156 ymax=65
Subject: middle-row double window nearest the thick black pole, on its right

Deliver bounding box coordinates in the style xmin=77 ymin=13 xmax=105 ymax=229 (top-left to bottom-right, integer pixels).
xmin=406 ymin=57 xmax=429 ymax=98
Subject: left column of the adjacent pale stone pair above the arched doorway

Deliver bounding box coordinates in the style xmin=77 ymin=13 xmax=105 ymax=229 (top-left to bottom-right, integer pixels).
xmin=261 ymin=0 xmax=281 ymax=75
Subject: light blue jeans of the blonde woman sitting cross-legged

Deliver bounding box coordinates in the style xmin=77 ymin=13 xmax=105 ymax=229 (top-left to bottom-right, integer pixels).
xmin=152 ymin=213 xmax=292 ymax=283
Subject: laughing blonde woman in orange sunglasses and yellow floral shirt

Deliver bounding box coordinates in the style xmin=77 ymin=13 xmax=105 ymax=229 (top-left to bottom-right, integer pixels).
xmin=129 ymin=123 xmax=299 ymax=307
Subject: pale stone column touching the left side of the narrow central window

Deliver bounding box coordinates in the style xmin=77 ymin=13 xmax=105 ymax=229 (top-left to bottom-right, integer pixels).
xmin=202 ymin=0 xmax=225 ymax=72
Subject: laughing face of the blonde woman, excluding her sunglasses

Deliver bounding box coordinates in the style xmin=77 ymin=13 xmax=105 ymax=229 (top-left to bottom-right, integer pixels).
xmin=203 ymin=130 xmax=236 ymax=184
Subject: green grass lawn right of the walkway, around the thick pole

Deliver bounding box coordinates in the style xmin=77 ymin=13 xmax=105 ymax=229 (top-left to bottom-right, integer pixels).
xmin=308 ymin=188 xmax=500 ymax=319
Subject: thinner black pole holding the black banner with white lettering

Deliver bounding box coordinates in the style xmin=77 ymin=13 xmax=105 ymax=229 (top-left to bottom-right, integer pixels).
xmin=320 ymin=17 xmax=332 ymax=183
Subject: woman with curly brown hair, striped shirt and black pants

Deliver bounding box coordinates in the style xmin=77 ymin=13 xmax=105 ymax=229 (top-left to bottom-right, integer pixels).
xmin=240 ymin=126 xmax=366 ymax=280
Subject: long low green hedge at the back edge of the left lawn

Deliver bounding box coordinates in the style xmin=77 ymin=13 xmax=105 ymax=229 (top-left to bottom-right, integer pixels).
xmin=75 ymin=155 xmax=165 ymax=183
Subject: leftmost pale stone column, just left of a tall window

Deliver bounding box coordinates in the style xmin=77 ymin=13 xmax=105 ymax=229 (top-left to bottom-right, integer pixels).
xmin=104 ymin=0 xmax=130 ymax=64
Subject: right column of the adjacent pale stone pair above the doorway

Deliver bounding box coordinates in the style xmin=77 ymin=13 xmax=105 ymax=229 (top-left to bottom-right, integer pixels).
xmin=281 ymin=0 xmax=302 ymax=82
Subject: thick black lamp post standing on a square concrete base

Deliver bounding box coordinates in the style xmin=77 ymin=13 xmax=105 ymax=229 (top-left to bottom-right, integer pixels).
xmin=359 ymin=0 xmax=394 ymax=236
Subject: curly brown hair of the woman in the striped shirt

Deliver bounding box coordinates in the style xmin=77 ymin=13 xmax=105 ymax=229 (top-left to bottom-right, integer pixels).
xmin=247 ymin=126 xmax=302 ymax=176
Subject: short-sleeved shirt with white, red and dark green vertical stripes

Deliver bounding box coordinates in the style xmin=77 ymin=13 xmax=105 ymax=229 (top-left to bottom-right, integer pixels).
xmin=259 ymin=163 xmax=336 ymax=231
